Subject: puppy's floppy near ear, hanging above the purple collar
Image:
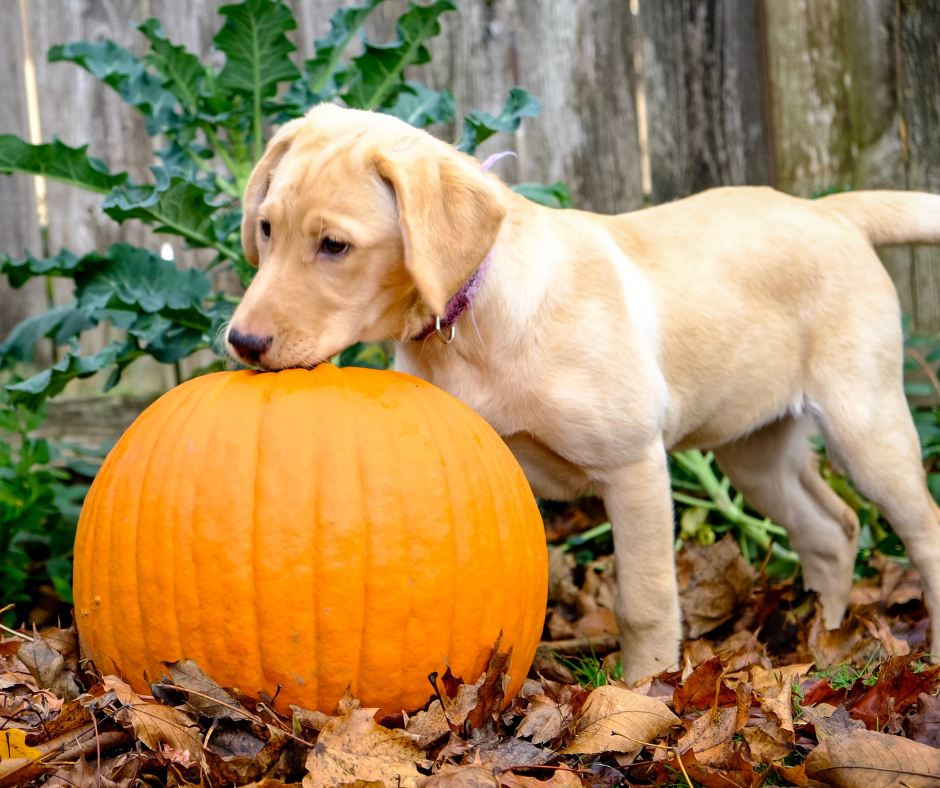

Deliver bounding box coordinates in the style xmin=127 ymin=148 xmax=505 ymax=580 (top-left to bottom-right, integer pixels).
xmin=375 ymin=143 xmax=506 ymax=316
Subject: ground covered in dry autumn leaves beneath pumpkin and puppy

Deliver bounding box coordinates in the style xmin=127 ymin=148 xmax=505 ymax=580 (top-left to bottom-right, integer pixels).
xmin=0 ymin=520 xmax=940 ymax=788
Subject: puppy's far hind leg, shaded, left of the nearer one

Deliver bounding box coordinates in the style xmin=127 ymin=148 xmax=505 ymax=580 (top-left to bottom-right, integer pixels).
xmin=715 ymin=416 xmax=858 ymax=628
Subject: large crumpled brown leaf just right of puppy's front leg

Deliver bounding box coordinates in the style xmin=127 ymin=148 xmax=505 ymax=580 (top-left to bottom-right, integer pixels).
xmin=676 ymin=534 xmax=754 ymax=639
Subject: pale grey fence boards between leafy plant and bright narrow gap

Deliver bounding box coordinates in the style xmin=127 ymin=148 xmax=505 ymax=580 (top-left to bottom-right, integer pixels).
xmin=416 ymin=0 xmax=643 ymax=213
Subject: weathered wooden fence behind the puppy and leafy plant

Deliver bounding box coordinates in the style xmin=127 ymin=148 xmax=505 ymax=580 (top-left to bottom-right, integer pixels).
xmin=0 ymin=0 xmax=940 ymax=400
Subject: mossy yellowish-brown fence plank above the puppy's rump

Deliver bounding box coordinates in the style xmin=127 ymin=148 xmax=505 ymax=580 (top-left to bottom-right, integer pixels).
xmin=764 ymin=0 xmax=852 ymax=197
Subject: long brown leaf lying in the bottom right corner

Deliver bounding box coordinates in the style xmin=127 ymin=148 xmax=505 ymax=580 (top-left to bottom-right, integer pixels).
xmin=806 ymin=730 xmax=940 ymax=788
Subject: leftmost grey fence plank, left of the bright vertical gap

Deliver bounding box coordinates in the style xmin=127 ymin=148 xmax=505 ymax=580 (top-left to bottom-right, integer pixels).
xmin=0 ymin=0 xmax=46 ymax=350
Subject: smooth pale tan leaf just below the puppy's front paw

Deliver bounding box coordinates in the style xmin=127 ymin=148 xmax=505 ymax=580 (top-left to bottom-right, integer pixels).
xmin=564 ymin=684 xmax=679 ymax=754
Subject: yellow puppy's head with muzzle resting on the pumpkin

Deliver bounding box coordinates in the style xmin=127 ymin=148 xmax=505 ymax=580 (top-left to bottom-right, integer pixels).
xmin=226 ymin=104 xmax=506 ymax=369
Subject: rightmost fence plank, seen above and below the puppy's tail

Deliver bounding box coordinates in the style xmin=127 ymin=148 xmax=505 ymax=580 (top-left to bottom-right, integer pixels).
xmin=899 ymin=0 xmax=940 ymax=332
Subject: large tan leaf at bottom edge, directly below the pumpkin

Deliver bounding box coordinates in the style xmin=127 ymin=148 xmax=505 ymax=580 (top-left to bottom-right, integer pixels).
xmin=303 ymin=709 xmax=429 ymax=788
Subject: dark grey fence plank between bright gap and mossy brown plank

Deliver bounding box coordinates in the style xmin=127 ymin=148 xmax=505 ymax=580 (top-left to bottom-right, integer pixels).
xmin=640 ymin=0 xmax=769 ymax=203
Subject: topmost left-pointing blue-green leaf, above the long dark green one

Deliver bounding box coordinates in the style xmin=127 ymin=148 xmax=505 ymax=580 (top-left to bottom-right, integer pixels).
xmin=49 ymin=41 xmax=182 ymax=136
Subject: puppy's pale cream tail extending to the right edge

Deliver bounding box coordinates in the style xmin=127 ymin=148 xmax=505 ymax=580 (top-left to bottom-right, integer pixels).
xmin=819 ymin=191 xmax=940 ymax=246
